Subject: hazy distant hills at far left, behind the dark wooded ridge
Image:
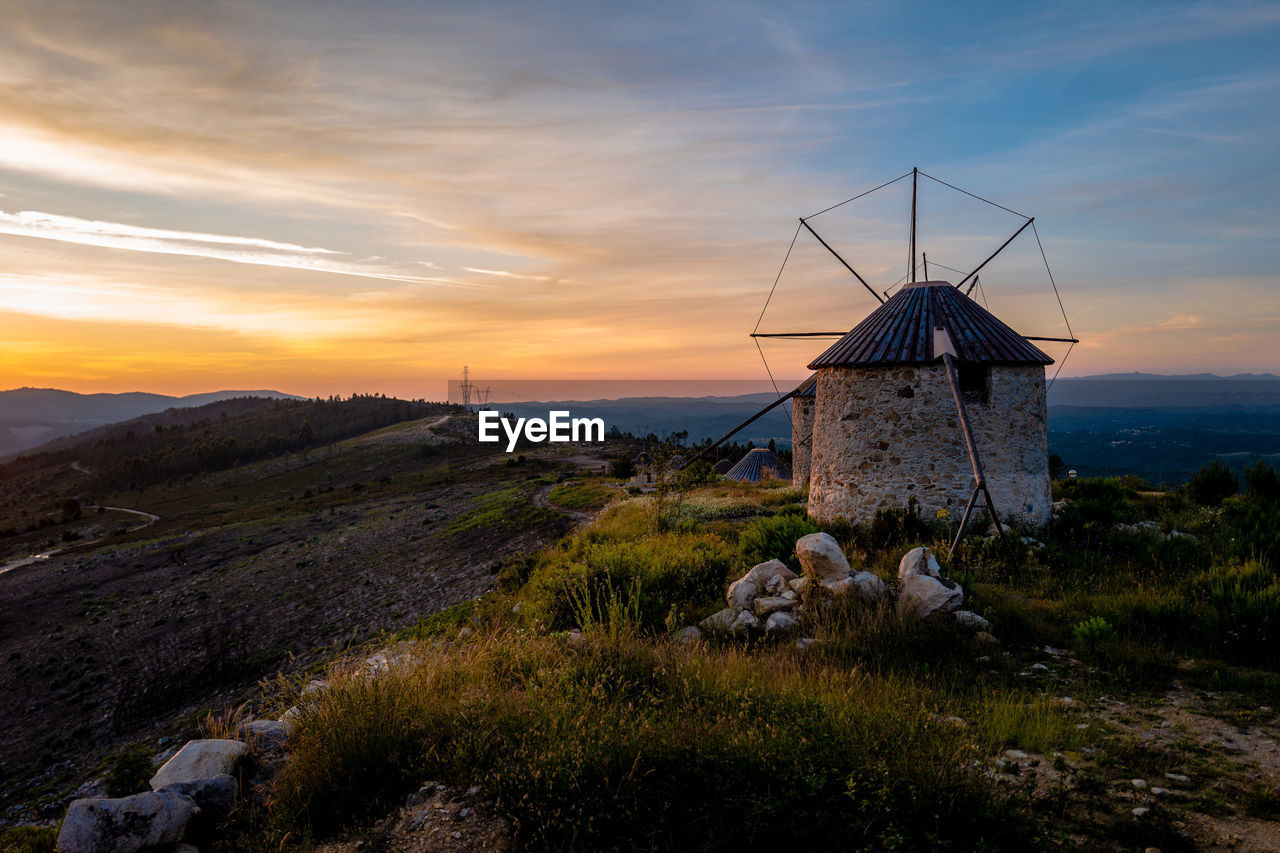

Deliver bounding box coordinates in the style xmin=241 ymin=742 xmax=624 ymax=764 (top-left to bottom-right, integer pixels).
xmin=0 ymin=388 xmax=300 ymax=456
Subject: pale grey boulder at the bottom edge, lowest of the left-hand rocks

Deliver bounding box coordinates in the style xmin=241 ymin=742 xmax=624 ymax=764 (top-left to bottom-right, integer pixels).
xmin=58 ymin=792 xmax=200 ymax=853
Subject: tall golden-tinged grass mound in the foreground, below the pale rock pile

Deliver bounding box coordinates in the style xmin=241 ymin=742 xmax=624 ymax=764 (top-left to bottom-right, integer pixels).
xmin=267 ymin=633 xmax=1051 ymax=850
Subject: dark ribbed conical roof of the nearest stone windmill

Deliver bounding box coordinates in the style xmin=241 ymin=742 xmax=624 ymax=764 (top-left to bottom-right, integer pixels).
xmin=809 ymin=282 xmax=1053 ymax=370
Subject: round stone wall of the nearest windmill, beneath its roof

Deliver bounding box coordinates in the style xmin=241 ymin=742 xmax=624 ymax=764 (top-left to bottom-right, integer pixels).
xmin=796 ymin=362 xmax=1051 ymax=525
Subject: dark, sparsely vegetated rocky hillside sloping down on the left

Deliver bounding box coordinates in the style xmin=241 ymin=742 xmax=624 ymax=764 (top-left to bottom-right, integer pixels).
xmin=0 ymin=419 xmax=611 ymax=822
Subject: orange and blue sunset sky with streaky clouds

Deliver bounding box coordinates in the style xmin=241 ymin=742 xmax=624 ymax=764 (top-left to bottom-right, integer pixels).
xmin=0 ymin=0 xmax=1280 ymax=398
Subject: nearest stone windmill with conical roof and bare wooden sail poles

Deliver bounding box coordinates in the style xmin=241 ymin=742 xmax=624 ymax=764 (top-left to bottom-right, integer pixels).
xmin=696 ymin=169 xmax=1078 ymax=560
